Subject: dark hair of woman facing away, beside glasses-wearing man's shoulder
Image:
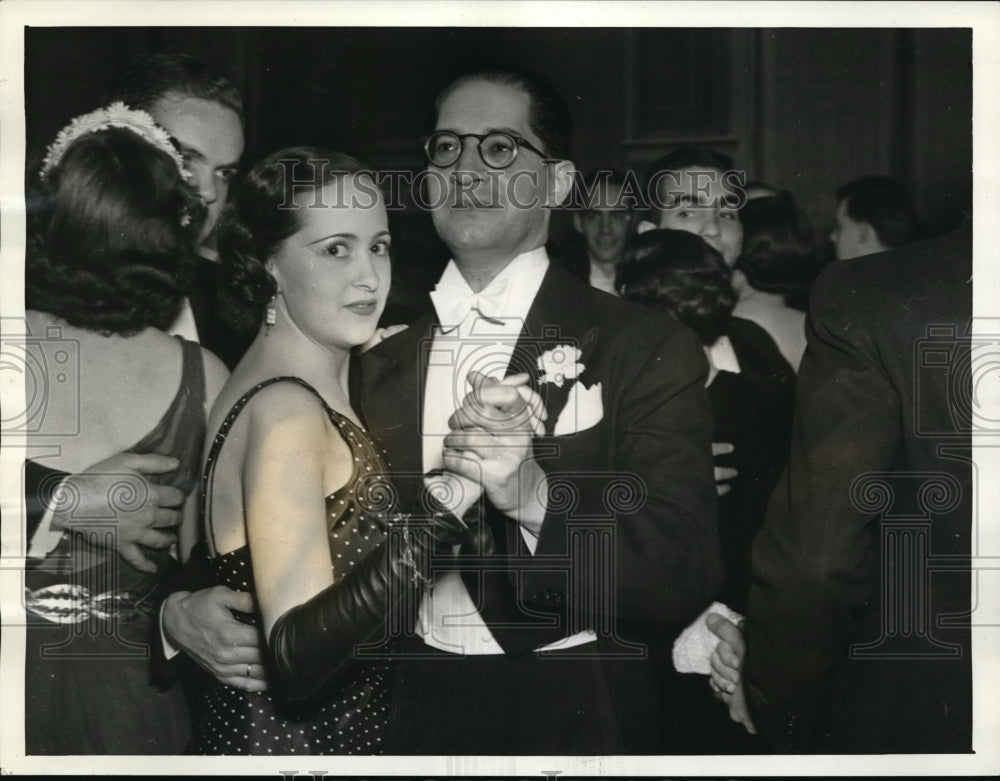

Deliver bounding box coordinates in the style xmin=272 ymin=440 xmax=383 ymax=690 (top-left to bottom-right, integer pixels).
xmin=616 ymin=229 xmax=736 ymax=345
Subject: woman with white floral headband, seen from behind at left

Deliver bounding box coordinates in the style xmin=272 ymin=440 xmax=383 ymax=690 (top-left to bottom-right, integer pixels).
xmin=25 ymin=104 xmax=227 ymax=755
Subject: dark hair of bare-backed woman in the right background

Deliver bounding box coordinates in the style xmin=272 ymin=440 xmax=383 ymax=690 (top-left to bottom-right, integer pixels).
xmin=736 ymin=190 xmax=817 ymax=299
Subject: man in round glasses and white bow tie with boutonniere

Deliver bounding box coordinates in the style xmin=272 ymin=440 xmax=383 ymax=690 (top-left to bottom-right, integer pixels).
xmin=358 ymin=69 xmax=721 ymax=755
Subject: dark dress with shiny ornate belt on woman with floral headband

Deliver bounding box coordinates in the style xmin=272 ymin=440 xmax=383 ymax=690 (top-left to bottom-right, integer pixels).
xmin=24 ymin=337 xmax=205 ymax=755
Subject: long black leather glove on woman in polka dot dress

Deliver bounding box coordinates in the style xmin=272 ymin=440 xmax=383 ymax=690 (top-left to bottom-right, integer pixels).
xmin=268 ymin=494 xmax=468 ymax=700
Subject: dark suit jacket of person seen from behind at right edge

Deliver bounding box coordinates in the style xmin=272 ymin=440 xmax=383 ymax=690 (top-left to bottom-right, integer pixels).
xmin=744 ymin=229 xmax=972 ymax=753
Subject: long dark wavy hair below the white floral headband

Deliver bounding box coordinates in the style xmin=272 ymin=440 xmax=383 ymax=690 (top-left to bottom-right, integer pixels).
xmin=25 ymin=127 xmax=205 ymax=336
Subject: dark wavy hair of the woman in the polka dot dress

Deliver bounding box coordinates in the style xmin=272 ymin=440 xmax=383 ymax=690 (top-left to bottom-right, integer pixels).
xmin=218 ymin=146 xmax=374 ymax=335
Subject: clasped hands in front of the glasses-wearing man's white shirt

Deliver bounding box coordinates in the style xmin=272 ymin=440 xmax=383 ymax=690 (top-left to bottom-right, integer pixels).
xmin=443 ymin=371 xmax=547 ymax=536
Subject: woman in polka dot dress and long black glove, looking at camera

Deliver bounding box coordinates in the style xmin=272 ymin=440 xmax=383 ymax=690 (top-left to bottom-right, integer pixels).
xmin=189 ymin=148 xmax=479 ymax=755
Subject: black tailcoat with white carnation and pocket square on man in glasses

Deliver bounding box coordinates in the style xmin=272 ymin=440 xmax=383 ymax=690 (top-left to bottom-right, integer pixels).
xmin=358 ymin=264 xmax=721 ymax=748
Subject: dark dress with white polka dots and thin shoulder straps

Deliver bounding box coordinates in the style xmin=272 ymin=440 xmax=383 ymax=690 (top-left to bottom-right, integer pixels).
xmin=188 ymin=378 xmax=389 ymax=756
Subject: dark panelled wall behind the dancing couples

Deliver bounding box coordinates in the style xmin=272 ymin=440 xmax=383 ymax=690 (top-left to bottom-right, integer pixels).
xmin=25 ymin=27 xmax=972 ymax=296
